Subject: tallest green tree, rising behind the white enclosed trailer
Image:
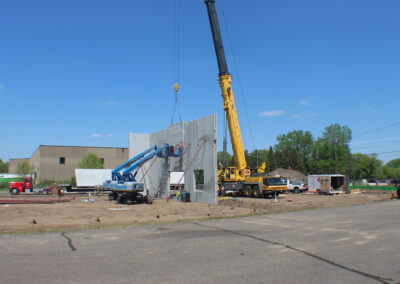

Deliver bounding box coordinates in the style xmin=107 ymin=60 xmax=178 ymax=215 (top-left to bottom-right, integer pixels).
xmin=313 ymin=123 xmax=351 ymax=174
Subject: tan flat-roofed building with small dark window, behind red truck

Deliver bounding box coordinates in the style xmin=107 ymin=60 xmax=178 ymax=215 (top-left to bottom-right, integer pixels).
xmin=9 ymin=145 xmax=129 ymax=181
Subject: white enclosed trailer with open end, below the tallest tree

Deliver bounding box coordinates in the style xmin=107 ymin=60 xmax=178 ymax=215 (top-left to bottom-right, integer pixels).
xmin=308 ymin=174 xmax=349 ymax=194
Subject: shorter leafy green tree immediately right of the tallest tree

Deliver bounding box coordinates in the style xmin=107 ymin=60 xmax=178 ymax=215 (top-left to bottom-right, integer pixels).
xmin=351 ymin=153 xmax=382 ymax=179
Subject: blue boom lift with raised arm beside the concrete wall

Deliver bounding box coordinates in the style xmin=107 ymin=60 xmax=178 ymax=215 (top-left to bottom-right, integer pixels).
xmin=103 ymin=142 xmax=183 ymax=204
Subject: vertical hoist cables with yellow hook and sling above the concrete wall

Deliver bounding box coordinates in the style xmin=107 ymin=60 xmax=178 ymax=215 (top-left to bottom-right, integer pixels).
xmin=171 ymin=0 xmax=182 ymax=125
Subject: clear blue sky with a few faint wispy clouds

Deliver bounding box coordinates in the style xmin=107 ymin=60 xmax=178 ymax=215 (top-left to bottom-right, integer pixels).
xmin=0 ymin=0 xmax=400 ymax=161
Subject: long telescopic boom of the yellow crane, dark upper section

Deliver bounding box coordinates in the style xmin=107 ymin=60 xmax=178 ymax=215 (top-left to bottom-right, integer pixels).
xmin=205 ymin=0 xmax=247 ymax=174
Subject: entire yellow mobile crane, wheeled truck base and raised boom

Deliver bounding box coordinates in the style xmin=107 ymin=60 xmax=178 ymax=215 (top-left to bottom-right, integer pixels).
xmin=205 ymin=0 xmax=287 ymax=197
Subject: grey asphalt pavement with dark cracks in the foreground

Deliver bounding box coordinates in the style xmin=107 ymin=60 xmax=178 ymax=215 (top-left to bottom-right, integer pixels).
xmin=0 ymin=201 xmax=400 ymax=283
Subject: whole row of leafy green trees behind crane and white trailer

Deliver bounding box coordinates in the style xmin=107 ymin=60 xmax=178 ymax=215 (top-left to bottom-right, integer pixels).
xmin=218 ymin=124 xmax=400 ymax=179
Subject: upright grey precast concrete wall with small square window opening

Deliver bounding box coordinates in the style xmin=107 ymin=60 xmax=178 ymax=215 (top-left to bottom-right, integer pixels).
xmin=129 ymin=114 xmax=217 ymax=204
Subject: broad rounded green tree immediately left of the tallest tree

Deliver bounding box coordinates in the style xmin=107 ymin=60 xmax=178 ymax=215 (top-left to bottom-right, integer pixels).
xmin=274 ymin=130 xmax=314 ymax=173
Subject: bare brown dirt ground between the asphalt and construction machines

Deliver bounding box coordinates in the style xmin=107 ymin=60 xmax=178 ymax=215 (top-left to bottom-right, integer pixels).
xmin=0 ymin=191 xmax=391 ymax=233
